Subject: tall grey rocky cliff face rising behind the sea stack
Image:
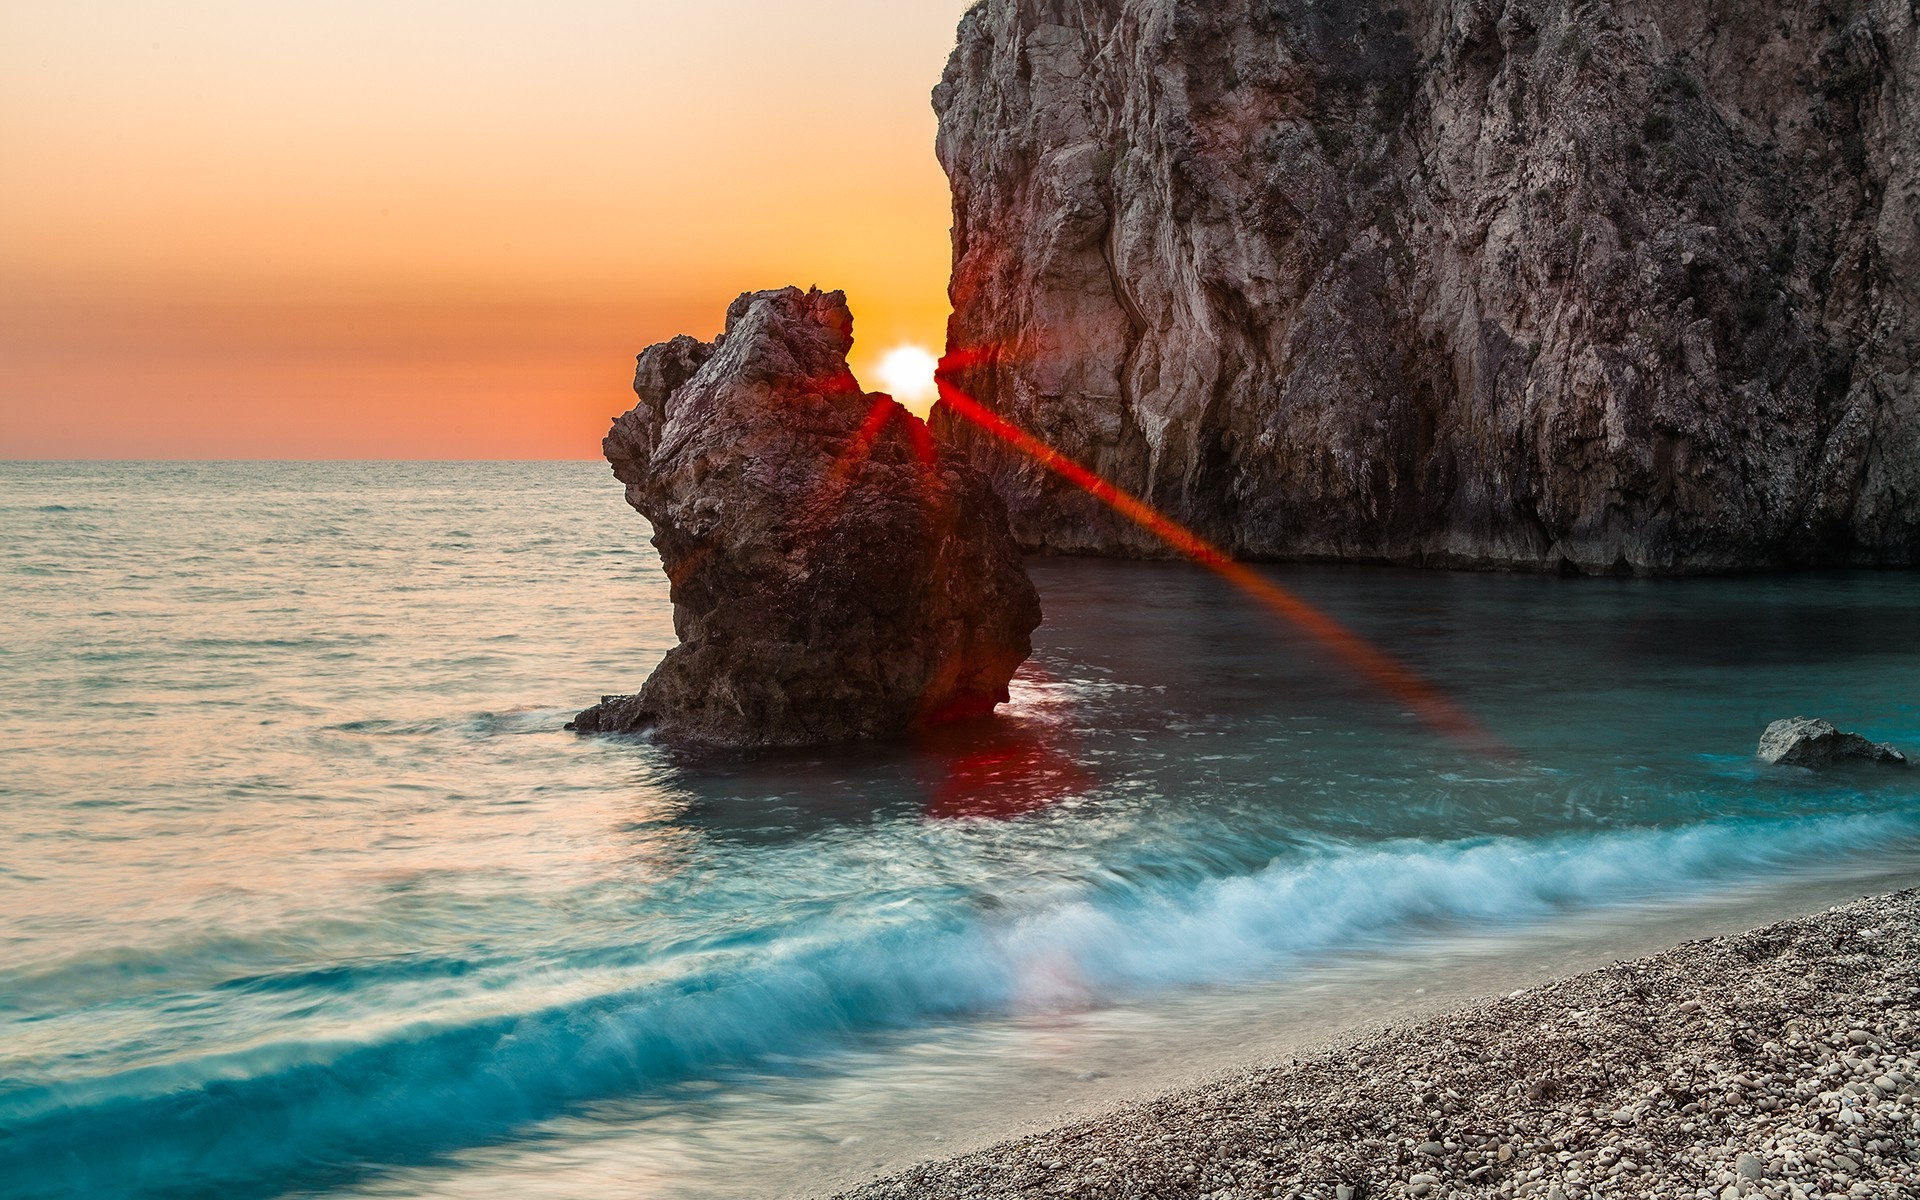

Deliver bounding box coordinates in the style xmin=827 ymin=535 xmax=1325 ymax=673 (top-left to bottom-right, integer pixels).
xmin=935 ymin=0 xmax=1920 ymax=572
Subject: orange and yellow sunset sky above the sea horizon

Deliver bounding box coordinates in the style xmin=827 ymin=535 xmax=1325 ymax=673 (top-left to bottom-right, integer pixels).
xmin=0 ymin=0 xmax=970 ymax=459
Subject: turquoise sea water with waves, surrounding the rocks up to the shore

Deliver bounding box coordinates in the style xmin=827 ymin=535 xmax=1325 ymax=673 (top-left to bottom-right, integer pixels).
xmin=0 ymin=463 xmax=1920 ymax=1200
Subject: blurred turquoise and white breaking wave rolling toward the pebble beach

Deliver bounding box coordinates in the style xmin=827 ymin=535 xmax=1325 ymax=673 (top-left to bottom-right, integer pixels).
xmin=0 ymin=814 xmax=1916 ymax=1196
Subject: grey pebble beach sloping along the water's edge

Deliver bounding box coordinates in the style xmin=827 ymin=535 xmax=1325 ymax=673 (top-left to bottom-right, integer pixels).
xmin=841 ymin=891 xmax=1920 ymax=1200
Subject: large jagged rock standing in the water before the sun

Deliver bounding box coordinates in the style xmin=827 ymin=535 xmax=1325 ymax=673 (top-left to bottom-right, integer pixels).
xmin=570 ymin=288 xmax=1041 ymax=745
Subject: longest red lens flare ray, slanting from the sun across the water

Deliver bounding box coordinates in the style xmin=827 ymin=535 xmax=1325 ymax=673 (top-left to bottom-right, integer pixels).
xmin=935 ymin=372 xmax=1513 ymax=758
